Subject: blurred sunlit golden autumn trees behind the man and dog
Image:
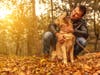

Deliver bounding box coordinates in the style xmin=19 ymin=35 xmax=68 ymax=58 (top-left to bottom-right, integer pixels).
xmin=0 ymin=0 xmax=100 ymax=56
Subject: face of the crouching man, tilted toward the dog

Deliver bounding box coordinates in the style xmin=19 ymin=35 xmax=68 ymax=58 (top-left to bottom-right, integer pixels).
xmin=70 ymin=7 xmax=83 ymax=20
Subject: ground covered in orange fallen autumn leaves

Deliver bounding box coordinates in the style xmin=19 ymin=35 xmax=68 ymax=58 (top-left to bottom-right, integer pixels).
xmin=0 ymin=52 xmax=100 ymax=75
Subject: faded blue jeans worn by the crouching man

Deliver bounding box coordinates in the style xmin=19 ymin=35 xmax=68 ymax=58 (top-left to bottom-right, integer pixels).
xmin=42 ymin=31 xmax=86 ymax=56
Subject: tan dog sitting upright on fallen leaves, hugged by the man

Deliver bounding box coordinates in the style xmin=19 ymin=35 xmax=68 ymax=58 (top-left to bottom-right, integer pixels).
xmin=52 ymin=18 xmax=75 ymax=64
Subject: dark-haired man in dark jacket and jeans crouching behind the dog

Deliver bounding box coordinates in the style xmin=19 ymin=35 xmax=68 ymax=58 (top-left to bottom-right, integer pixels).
xmin=43 ymin=5 xmax=88 ymax=56
